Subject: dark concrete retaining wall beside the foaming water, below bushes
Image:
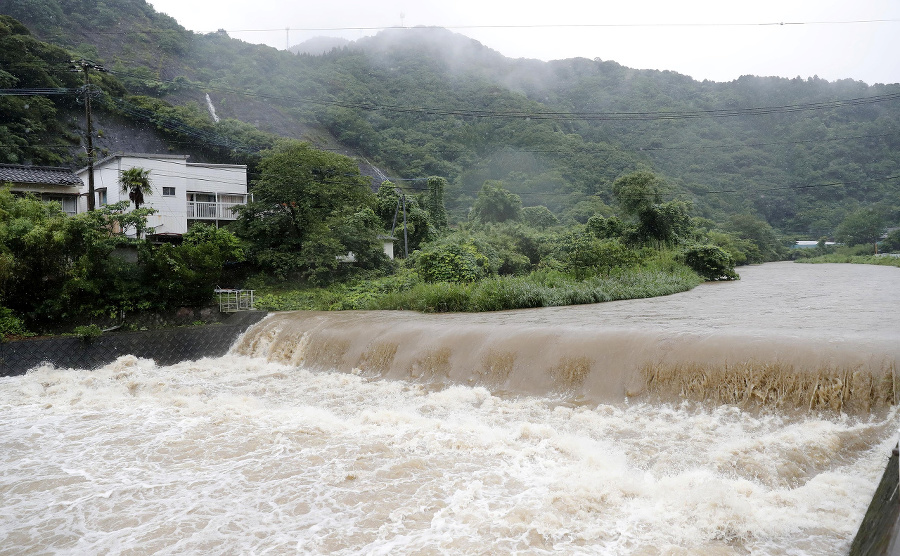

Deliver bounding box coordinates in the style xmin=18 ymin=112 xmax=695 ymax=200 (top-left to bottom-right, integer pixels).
xmin=0 ymin=311 xmax=266 ymax=376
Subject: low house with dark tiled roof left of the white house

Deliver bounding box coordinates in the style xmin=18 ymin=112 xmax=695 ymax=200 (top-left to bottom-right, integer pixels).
xmin=0 ymin=164 xmax=82 ymax=216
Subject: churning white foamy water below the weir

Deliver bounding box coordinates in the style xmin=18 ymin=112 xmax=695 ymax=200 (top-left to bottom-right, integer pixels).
xmin=0 ymin=356 xmax=896 ymax=555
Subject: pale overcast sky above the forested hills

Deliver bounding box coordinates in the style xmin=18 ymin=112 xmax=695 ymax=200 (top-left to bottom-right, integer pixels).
xmin=148 ymin=0 xmax=900 ymax=84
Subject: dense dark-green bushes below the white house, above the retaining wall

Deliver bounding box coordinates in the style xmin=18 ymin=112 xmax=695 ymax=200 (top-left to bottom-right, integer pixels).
xmin=0 ymin=189 xmax=243 ymax=334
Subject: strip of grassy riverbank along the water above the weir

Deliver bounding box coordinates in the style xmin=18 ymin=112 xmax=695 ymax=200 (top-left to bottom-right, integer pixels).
xmin=256 ymin=263 xmax=704 ymax=313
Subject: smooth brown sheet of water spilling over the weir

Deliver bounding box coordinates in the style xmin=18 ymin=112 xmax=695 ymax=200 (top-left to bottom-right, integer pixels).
xmin=234 ymin=306 xmax=898 ymax=413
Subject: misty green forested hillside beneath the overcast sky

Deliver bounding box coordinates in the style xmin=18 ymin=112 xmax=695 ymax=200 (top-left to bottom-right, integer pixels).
xmin=0 ymin=0 xmax=900 ymax=238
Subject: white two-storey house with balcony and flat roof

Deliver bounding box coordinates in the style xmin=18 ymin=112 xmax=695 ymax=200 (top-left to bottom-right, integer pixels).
xmin=76 ymin=154 xmax=248 ymax=234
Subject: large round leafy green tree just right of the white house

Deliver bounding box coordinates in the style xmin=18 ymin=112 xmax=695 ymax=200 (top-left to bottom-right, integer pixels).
xmin=235 ymin=141 xmax=384 ymax=282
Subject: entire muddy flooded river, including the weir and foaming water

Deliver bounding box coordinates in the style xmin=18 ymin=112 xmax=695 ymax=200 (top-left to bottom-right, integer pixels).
xmin=0 ymin=263 xmax=900 ymax=555
